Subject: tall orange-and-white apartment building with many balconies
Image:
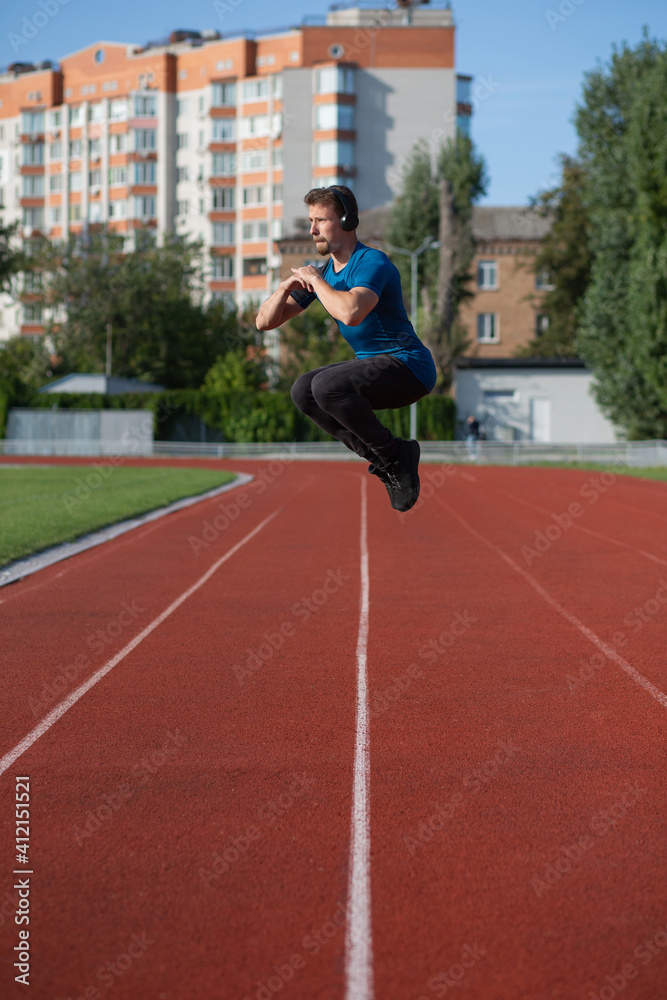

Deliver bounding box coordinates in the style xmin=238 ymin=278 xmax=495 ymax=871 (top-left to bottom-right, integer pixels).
xmin=0 ymin=2 xmax=472 ymax=339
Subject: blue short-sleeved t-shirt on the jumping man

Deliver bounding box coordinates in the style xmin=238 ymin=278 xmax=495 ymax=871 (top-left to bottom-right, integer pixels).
xmin=291 ymin=243 xmax=436 ymax=392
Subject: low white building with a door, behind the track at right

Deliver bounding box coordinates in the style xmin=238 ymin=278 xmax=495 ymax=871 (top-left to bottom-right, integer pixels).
xmin=454 ymin=358 xmax=619 ymax=444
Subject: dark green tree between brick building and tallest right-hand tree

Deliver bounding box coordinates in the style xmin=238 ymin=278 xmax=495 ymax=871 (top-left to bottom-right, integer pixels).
xmin=516 ymin=155 xmax=592 ymax=358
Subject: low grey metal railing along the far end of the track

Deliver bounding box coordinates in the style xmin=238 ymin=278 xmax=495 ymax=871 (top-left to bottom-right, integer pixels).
xmin=0 ymin=438 xmax=667 ymax=468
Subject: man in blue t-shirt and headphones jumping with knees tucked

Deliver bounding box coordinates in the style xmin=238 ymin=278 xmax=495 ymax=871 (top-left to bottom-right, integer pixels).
xmin=257 ymin=185 xmax=436 ymax=511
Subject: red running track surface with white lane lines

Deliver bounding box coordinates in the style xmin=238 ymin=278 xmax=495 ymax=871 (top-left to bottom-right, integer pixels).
xmin=0 ymin=462 xmax=667 ymax=1000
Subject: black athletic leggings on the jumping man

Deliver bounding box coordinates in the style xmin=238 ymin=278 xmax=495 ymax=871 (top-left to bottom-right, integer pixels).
xmin=292 ymin=354 xmax=429 ymax=466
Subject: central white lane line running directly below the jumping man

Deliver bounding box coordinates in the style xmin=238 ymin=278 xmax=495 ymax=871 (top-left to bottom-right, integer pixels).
xmin=345 ymin=479 xmax=373 ymax=1000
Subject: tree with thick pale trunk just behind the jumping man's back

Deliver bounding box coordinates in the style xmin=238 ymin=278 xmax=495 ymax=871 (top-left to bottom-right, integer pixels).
xmin=388 ymin=133 xmax=486 ymax=390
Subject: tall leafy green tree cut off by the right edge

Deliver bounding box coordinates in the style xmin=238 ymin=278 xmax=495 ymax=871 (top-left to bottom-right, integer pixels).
xmin=576 ymin=31 xmax=667 ymax=438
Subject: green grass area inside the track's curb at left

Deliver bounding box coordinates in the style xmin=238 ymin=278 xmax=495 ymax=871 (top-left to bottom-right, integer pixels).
xmin=0 ymin=463 xmax=234 ymax=566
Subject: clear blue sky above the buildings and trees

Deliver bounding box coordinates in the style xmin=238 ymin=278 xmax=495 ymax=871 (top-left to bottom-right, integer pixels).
xmin=0 ymin=0 xmax=667 ymax=205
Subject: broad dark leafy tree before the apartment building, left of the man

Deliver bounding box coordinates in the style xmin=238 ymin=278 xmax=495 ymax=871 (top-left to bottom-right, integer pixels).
xmin=36 ymin=230 xmax=238 ymax=388
